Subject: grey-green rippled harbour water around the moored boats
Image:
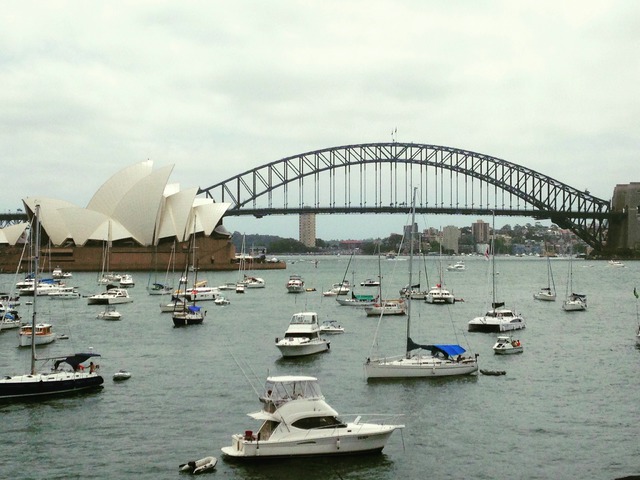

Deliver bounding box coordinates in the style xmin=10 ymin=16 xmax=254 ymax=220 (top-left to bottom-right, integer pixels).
xmin=0 ymin=256 xmax=640 ymax=480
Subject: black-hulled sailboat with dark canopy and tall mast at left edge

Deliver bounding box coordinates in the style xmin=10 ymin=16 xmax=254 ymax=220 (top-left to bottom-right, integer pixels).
xmin=0 ymin=205 xmax=104 ymax=400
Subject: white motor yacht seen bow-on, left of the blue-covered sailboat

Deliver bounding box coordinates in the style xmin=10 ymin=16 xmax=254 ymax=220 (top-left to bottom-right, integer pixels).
xmin=276 ymin=312 xmax=330 ymax=357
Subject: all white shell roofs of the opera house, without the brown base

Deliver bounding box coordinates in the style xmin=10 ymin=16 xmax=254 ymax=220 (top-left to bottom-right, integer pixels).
xmin=6 ymin=161 xmax=230 ymax=246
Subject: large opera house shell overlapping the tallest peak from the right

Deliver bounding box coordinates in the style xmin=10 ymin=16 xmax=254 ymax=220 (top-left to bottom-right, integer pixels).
xmin=111 ymin=165 xmax=173 ymax=245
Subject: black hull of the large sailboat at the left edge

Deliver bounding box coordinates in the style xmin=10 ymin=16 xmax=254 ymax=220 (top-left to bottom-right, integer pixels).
xmin=0 ymin=372 xmax=104 ymax=400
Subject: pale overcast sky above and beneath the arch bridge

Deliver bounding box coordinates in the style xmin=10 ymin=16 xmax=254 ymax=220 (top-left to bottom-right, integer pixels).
xmin=0 ymin=0 xmax=640 ymax=240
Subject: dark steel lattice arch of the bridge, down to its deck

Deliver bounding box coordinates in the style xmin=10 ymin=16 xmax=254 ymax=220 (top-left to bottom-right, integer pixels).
xmin=199 ymin=142 xmax=615 ymax=250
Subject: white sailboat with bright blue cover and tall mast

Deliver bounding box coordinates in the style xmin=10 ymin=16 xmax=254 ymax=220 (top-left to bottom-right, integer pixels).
xmin=364 ymin=189 xmax=478 ymax=379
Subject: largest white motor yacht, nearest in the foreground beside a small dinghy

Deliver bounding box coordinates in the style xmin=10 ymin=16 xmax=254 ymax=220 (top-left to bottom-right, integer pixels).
xmin=222 ymin=376 xmax=404 ymax=460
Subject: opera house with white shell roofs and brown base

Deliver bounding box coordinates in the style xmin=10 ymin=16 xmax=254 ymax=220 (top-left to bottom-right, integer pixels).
xmin=0 ymin=161 xmax=274 ymax=273
